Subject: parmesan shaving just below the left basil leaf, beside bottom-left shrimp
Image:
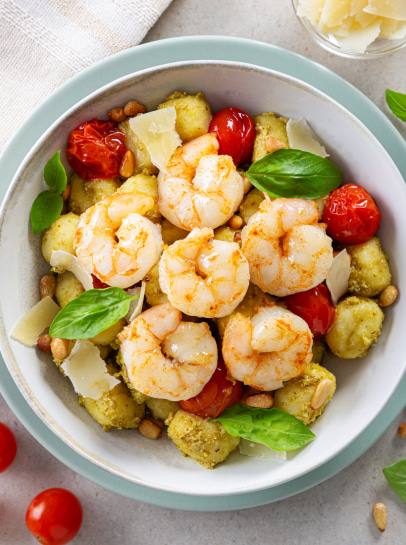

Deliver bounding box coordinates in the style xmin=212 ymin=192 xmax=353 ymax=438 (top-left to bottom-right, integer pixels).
xmin=61 ymin=340 xmax=120 ymax=400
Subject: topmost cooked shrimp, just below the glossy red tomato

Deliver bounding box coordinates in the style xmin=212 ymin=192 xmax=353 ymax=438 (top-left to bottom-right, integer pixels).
xmin=158 ymin=133 xmax=244 ymax=231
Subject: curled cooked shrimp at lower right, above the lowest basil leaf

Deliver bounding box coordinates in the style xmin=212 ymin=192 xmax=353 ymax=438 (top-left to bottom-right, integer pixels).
xmin=223 ymin=305 xmax=313 ymax=391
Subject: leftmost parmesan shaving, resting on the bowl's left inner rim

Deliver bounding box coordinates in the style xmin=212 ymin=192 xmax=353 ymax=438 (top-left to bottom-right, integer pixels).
xmin=11 ymin=295 xmax=61 ymax=347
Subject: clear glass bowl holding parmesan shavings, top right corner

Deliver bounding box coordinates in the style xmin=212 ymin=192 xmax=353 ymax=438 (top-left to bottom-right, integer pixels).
xmin=292 ymin=0 xmax=406 ymax=59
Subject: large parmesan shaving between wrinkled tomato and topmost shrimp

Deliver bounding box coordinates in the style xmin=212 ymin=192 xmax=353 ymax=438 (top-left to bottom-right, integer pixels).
xmin=129 ymin=106 xmax=182 ymax=170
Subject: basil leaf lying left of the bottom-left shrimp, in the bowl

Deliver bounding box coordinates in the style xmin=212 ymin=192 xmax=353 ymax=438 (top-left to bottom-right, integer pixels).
xmin=49 ymin=288 xmax=138 ymax=339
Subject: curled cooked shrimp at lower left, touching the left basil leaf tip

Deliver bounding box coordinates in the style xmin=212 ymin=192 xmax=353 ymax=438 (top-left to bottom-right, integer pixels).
xmin=118 ymin=303 xmax=217 ymax=401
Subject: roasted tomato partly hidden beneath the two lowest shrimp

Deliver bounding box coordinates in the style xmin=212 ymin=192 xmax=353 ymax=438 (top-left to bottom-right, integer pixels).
xmin=179 ymin=362 xmax=242 ymax=418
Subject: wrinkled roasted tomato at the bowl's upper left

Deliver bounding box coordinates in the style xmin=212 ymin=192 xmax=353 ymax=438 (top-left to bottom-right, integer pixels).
xmin=66 ymin=119 xmax=127 ymax=181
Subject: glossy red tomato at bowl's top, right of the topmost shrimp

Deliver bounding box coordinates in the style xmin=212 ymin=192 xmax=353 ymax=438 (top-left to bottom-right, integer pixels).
xmin=209 ymin=108 xmax=255 ymax=166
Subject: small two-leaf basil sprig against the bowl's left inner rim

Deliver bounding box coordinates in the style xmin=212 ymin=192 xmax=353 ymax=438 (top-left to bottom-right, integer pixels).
xmin=30 ymin=151 xmax=67 ymax=235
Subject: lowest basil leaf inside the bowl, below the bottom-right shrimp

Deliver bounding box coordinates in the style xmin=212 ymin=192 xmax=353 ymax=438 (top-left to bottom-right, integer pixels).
xmin=213 ymin=405 xmax=315 ymax=450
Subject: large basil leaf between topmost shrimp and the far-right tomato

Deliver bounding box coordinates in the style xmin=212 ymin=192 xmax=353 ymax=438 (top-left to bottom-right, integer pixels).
xmin=245 ymin=149 xmax=343 ymax=199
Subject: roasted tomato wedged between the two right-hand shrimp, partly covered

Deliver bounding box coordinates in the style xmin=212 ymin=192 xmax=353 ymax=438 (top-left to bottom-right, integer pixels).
xmin=284 ymin=284 xmax=336 ymax=339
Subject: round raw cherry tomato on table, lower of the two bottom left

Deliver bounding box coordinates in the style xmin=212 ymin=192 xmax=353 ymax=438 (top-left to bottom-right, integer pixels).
xmin=25 ymin=488 xmax=83 ymax=545
